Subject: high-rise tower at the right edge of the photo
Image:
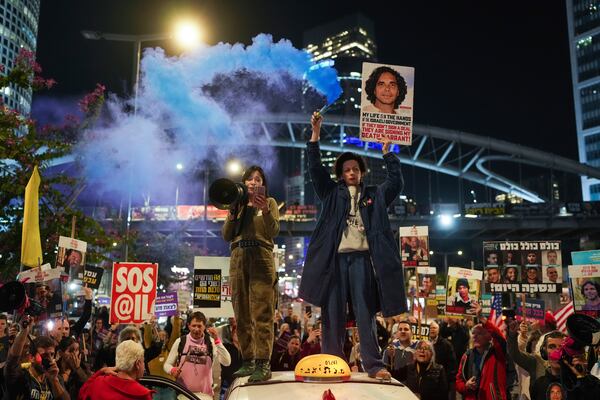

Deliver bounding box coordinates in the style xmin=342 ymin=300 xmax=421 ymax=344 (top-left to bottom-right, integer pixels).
xmin=567 ymin=0 xmax=600 ymax=201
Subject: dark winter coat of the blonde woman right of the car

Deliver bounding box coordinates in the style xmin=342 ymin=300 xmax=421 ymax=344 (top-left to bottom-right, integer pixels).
xmin=406 ymin=361 xmax=448 ymax=400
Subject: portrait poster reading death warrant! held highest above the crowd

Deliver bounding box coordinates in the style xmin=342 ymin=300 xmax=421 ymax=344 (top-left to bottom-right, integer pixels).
xmin=360 ymin=62 xmax=415 ymax=145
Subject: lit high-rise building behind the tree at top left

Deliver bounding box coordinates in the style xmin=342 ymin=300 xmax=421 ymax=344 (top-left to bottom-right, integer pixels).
xmin=0 ymin=0 xmax=40 ymax=115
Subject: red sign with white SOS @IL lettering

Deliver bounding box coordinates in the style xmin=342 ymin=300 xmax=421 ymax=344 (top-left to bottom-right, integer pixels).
xmin=110 ymin=263 xmax=158 ymax=324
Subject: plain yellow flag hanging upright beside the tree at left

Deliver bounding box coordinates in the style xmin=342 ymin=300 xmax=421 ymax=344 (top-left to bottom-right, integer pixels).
xmin=21 ymin=166 xmax=42 ymax=267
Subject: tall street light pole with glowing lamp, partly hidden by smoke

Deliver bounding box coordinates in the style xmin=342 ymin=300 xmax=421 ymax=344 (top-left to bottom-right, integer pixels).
xmin=81 ymin=21 xmax=200 ymax=261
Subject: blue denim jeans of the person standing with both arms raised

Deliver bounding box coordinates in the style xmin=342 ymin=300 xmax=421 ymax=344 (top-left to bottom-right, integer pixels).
xmin=321 ymin=251 xmax=386 ymax=374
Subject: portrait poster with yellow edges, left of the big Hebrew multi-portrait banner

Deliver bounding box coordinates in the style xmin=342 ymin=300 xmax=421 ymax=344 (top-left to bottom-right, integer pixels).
xmin=446 ymin=267 xmax=482 ymax=316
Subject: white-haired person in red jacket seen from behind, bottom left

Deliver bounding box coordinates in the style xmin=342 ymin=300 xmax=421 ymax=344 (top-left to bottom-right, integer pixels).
xmin=79 ymin=340 xmax=153 ymax=400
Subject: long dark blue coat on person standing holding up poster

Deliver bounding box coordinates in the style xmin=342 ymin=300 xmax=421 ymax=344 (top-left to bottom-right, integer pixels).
xmin=298 ymin=142 xmax=407 ymax=317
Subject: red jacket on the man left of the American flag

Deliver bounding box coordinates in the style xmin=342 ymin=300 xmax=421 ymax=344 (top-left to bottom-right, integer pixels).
xmin=456 ymin=321 xmax=507 ymax=400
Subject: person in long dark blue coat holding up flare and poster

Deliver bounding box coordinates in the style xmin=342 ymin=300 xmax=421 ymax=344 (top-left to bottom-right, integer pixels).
xmin=298 ymin=113 xmax=407 ymax=380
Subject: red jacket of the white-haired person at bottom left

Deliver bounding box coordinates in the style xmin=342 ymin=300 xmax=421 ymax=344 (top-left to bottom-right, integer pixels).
xmin=79 ymin=371 xmax=154 ymax=400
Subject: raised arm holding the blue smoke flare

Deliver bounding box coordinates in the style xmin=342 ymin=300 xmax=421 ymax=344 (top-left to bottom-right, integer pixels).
xmin=306 ymin=112 xmax=335 ymax=200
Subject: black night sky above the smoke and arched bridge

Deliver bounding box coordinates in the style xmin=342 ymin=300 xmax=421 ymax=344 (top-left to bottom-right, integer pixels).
xmin=36 ymin=0 xmax=577 ymax=159
